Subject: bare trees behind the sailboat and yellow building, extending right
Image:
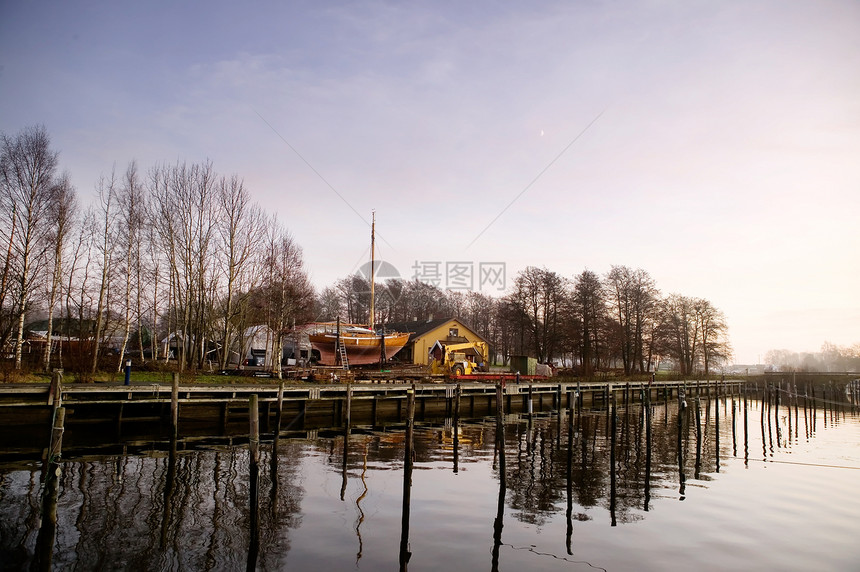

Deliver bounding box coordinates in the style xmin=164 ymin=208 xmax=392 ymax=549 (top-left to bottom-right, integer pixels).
xmin=317 ymin=266 xmax=731 ymax=376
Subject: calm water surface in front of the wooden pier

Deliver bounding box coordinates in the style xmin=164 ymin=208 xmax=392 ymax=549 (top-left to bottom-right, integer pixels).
xmin=0 ymin=398 xmax=860 ymax=571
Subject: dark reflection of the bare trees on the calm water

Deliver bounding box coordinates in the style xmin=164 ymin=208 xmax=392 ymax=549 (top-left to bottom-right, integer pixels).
xmin=5 ymin=388 xmax=840 ymax=570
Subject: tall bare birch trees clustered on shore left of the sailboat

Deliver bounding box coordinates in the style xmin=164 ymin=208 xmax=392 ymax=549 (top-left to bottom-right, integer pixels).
xmin=0 ymin=126 xmax=314 ymax=376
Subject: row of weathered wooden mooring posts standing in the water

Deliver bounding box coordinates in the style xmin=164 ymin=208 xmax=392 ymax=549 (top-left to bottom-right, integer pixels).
xmin=28 ymin=375 xmax=860 ymax=570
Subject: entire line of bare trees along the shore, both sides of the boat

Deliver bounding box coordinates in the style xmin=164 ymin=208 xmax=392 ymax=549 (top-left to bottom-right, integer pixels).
xmin=0 ymin=126 xmax=730 ymax=379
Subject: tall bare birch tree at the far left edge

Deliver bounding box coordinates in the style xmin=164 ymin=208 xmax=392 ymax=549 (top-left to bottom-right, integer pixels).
xmin=0 ymin=126 xmax=58 ymax=369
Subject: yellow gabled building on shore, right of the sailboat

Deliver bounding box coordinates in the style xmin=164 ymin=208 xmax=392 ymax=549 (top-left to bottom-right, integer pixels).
xmin=385 ymin=318 xmax=490 ymax=365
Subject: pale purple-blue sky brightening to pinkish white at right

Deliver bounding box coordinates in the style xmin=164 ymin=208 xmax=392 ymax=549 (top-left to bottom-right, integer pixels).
xmin=0 ymin=0 xmax=860 ymax=363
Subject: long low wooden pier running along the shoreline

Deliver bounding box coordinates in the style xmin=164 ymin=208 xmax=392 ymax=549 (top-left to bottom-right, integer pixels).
xmin=0 ymin=379 xmax=744 ymax=425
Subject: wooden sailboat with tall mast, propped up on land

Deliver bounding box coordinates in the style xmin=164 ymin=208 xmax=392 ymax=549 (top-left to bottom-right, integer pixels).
xmin=308 ymin=212 xmax=409 ymax=368
